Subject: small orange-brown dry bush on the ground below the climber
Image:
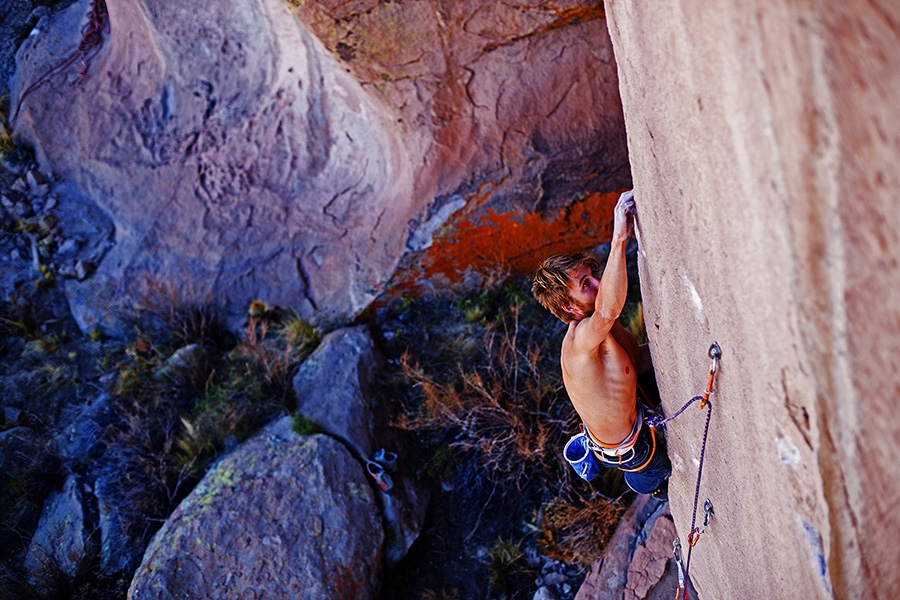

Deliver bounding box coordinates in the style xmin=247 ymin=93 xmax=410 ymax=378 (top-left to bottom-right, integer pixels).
xmin=539 ymin=493 xmax=625 ymax=566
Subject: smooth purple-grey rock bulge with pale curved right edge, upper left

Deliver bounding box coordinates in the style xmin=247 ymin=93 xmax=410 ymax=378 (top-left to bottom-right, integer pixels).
xmin=14 ymin=0 xmax=417 ymax=327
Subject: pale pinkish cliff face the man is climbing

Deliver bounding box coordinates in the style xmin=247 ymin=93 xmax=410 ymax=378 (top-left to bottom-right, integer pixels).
xmin=606 ymin=0 xmax=900 ymax=598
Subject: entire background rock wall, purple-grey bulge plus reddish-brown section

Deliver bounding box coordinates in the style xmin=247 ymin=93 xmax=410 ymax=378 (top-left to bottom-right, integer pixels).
xmin=12 ymin=0 xmax=630 ymax=328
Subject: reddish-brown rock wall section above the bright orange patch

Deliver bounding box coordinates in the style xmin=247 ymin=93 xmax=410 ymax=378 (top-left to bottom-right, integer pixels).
xmin=292 ymin=0 xmax=630 ymax=212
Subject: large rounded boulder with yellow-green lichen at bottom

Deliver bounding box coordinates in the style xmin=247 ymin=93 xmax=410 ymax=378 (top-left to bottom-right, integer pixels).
xmin=128 ymin=417 xmax=384 ymax=600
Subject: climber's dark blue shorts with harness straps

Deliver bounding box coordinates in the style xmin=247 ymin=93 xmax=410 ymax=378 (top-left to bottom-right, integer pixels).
xmin=592 ymin=422 xmax=672 ymax=494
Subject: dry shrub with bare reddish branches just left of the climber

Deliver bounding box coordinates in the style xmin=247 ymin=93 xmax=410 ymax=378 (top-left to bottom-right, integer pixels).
xmin=395 ymin=305 xmax=574 ymax=493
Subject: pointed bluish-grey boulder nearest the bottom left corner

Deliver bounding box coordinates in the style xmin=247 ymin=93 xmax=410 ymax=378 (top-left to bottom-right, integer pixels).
xmin=25 ymin=475 xmax=94 ymax=591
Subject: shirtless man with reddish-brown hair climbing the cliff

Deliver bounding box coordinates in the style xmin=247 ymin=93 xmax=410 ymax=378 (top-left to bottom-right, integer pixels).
xmin=532 ymin=191 xmax=672 ymax=499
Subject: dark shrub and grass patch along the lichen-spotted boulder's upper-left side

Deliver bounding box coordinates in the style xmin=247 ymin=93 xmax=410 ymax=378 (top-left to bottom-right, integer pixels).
xmin=105 ymin=302 xmax=320 ymax=527
